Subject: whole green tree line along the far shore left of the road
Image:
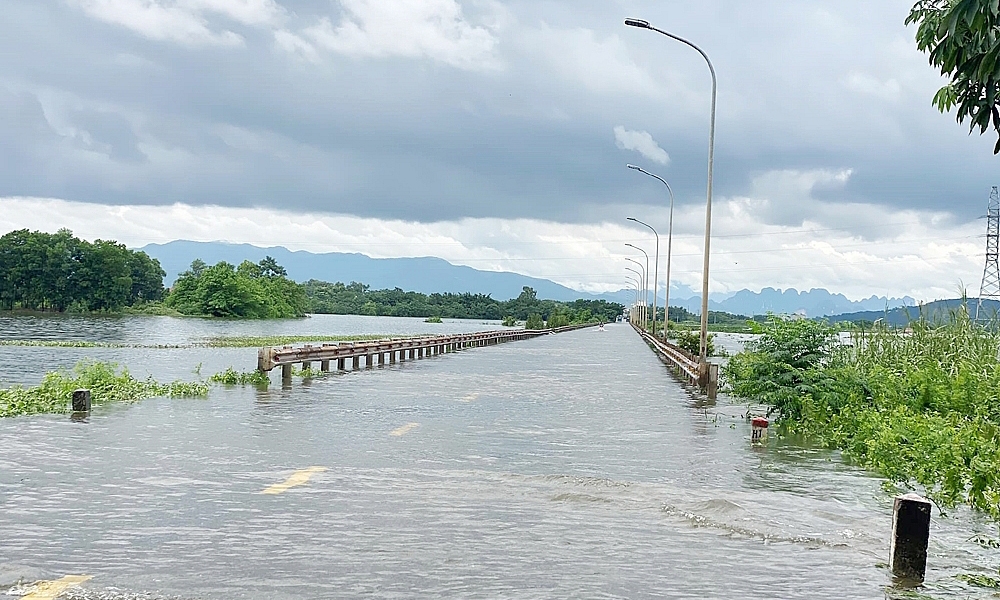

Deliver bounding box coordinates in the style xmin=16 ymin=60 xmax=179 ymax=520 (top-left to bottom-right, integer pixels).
xmin=0 ymin=229 xmax=622 ymax=327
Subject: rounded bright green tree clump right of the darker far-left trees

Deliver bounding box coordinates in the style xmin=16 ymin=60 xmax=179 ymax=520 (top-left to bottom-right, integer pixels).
xmin=164 ymin=257 xmax=306 ymax=319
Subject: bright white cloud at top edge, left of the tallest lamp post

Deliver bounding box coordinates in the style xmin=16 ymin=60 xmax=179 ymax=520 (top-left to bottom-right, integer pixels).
xmin=292 ymin=0 xmax=500 ymax=70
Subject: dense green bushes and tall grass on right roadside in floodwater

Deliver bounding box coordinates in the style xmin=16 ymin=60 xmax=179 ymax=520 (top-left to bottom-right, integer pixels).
xmin=723 ymin=309 xmax=1000 ymax=519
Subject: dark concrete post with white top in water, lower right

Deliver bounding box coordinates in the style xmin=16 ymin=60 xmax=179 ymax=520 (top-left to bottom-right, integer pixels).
xmin=889 ymin=493 xmax=931 ymax=581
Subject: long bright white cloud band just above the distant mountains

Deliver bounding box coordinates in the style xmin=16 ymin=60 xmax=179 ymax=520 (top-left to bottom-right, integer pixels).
xmin=0 ymin=197 xmax=983 ymax=300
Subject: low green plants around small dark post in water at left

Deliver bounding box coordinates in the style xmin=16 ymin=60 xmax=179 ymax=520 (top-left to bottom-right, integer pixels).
xmin=0 ymin=362 xmax=208 ymax=417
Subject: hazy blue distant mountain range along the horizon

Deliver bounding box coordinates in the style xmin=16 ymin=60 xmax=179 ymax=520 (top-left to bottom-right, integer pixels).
xmin=142 ymin=240 xmax=916 ymax=318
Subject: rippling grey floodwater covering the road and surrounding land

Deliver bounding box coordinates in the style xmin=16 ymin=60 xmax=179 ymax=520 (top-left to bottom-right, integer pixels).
xmin=0 ymin=317 xmax=997 ymax=600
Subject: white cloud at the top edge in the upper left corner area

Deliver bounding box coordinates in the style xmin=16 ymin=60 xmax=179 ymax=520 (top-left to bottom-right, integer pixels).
xmin=70 ymin=0 xmax=284 ymax=46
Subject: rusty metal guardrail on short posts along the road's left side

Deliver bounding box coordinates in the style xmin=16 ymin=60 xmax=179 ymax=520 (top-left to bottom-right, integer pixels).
xmin=257 ymin=323 xmax=597 ymax=379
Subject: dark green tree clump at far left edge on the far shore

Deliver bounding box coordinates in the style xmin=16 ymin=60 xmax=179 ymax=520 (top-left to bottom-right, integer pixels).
xmin=0 ymin=229 xmax=164 ymax=312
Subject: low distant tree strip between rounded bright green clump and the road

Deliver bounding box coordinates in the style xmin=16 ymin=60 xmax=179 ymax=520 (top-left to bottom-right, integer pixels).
xmin=305 ymin=280 xmax=622 ymax=323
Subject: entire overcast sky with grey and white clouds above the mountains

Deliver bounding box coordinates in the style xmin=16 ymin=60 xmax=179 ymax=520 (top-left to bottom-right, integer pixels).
xmin=0 ymin=0 xmax=997 ymax=300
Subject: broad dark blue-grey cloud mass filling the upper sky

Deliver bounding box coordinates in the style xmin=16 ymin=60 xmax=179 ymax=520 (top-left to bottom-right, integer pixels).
xmin=0 ymin=0 xmax=995 ymax=222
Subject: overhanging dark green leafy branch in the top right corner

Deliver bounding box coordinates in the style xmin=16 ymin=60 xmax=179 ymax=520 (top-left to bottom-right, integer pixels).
xmin=906 ymin=0 xmax=1000 ymax=154
